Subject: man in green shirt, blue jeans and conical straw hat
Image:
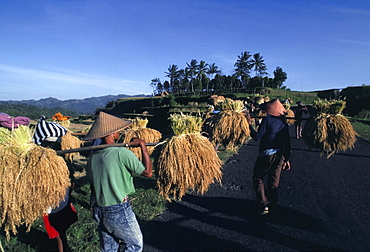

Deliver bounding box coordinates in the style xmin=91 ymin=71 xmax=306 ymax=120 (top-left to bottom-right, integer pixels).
xmin=85 ymin=112 xmax=152 ymax=251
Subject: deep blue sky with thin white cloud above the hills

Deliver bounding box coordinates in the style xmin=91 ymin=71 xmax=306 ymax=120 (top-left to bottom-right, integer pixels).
xmin=0 ymin=0 xmax=370 ymax=100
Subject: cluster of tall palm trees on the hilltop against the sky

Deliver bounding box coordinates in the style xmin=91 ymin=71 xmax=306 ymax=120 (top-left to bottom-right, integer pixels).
xmin=150 ymin=51 xmax=287 ymax=94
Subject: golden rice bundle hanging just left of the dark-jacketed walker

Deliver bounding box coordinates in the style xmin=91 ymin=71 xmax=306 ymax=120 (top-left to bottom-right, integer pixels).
xmin=207 ymin=101 xmax=250 ymax=149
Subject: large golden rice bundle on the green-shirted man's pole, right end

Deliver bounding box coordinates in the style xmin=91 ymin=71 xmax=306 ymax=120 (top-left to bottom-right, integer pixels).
xmin=156 ymin=114 xmax=222 ymax=201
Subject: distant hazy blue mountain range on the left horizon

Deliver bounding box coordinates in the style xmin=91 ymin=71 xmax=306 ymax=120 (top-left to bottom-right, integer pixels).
xmin=0 ymin=94 xmax=150 ymax=114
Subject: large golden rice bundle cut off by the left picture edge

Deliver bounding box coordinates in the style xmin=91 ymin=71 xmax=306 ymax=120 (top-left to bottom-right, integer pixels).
xmin=0 ymin=126 xmax=70 ymax=239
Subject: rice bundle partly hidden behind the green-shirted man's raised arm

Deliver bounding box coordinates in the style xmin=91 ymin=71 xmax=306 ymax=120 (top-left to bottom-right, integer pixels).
xmin=120 ymin=117 xmax=162 ymax=161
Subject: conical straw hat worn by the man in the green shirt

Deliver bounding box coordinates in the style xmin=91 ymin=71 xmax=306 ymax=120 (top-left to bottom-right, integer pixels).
xmin=84 ymin=111 xmax=132 ymax=140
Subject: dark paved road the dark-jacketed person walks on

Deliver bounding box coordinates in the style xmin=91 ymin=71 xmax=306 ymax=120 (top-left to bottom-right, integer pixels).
xmin=142 ymin=126 xmax=370 ymax=251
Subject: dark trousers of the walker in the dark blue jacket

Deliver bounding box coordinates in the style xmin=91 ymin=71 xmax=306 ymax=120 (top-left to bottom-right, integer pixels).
xmin=253 ymin=152 xmax=284 ymax=206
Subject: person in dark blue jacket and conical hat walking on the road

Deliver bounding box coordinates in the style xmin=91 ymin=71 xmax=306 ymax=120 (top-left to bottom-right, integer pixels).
xmin=246 ymin=99 xmax=290 ymax=215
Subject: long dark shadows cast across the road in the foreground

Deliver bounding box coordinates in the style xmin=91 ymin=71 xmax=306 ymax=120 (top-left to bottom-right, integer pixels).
xmin=143 ymin=195 xmax=338 ymax=251
